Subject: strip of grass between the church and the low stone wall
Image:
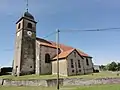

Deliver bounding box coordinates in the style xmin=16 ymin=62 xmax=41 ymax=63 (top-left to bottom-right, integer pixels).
xmin=0 ymin=72 xmax=120 ymax=80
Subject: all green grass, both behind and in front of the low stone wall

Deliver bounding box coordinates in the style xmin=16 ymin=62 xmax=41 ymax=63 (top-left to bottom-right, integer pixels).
xmin=0 ymin=72 xmax=120 ymax=90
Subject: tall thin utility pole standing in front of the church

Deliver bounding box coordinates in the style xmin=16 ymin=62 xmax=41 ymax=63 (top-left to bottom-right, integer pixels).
xmin=56 ymin=29 xmax=60 ymax=90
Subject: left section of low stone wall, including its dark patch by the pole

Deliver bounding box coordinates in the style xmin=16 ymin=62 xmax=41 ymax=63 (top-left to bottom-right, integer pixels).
xmin=1 ymin=79 xmax=63 ymax=87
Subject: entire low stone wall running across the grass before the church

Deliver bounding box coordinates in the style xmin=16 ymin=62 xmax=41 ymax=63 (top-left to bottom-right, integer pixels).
xmin=0 ymin=78 xmax=120 ymax=87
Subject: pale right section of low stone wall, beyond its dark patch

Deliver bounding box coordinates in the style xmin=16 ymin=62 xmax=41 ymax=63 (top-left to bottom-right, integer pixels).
xmin=63 ymin=78 xmax=120 ymax=86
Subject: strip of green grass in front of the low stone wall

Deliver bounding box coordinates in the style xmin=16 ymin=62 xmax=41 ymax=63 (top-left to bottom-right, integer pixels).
xmin=0 ymin=84 xmax=120 ymax=90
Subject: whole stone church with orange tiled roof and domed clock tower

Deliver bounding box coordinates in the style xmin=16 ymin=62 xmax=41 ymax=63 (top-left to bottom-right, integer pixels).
xmin=12 ymin=11 xmax=93 ymax=76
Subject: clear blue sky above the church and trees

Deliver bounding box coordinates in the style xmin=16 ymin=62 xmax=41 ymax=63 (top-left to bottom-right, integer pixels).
xmin=0 ymin=0 xmax=120 ymax=66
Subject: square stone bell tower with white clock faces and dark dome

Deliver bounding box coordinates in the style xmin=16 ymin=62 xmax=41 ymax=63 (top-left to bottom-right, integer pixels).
xmin=13 ymin=10 xmax=37 ymax=76
